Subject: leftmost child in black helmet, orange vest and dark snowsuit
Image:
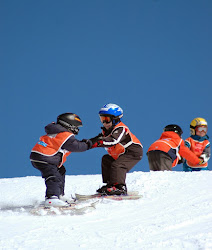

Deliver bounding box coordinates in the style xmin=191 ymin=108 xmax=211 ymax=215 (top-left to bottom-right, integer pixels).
xmin=30 ymin=113 xmax=92 ymax=206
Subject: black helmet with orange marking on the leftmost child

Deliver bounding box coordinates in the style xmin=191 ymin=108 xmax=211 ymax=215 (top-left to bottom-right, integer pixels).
xmin=57 ymin=113 xmax=82 ymax=135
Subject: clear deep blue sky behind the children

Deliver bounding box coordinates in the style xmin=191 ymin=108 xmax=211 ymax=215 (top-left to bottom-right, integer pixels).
xmin=0 ymin=0 xmax=212 ymax=178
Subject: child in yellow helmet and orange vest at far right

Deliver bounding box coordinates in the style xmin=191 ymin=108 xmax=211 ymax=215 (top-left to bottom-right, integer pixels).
xmin=183 ymin=117 xmax=211 ymax=172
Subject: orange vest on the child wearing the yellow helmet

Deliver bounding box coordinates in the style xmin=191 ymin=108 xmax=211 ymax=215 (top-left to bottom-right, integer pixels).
xmin=185 ymin=137 xmax=209 ymax=168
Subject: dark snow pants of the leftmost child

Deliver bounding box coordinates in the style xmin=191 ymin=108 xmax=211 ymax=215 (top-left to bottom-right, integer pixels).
xmin=31 ymin=161 xmax=66 ymax=198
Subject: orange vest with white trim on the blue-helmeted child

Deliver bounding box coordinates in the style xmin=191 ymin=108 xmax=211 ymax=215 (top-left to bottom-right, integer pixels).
xmin=103 ymin=122 xmax=143 ymax=160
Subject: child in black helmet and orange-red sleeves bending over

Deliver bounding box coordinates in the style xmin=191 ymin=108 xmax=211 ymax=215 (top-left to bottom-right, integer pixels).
xmin=147 ymin=124 xmax=203 ymax=171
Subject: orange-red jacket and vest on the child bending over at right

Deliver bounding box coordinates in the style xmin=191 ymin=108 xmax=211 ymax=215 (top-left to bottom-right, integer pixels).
xmin=148 ymin=131 xmax=200 ymax=167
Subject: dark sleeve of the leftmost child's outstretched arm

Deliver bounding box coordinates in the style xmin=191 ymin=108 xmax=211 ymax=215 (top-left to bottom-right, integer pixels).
xmin=62 ymin=136 xmax=89 ymax=152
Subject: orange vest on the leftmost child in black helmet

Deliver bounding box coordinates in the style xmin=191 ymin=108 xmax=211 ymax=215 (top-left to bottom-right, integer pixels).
xmin=32 ymin=132 xmax=74 ymax=168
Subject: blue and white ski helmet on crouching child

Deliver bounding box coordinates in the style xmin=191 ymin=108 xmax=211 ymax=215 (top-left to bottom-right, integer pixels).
xmin=99 ymin=103 xmax=123 ymax=125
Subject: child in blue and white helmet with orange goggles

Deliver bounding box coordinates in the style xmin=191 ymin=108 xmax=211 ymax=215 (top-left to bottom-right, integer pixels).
xmin=88 ymin=103 xmax=143 ymax=195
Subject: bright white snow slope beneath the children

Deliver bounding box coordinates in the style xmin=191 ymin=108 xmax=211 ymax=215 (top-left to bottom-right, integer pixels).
xmin=0 ymin=171 xmax=212 ymax=250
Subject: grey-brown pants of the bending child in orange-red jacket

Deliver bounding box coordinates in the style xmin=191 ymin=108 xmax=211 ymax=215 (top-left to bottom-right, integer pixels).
xmin=147 ymin=150 xmax=172 ymax=171
